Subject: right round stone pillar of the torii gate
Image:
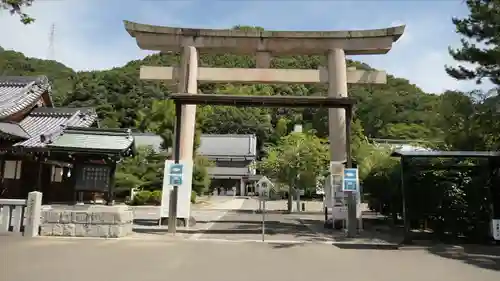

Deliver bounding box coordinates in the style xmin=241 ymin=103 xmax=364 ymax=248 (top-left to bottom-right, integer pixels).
xmin=328 ymin=49 xmax=358 ymax=236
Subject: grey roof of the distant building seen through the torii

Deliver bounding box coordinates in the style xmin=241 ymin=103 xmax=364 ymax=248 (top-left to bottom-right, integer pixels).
xmin=198 ymin=134 xmax=257 ymax=158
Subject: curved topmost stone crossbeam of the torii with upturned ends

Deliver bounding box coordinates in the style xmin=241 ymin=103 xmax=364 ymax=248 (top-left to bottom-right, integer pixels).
xmin=124 ymin=21 xmax=405 ymax=56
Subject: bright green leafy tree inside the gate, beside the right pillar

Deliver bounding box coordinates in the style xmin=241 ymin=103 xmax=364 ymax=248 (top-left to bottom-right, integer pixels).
xmin=257 ymin=132 xmax=329 ymax=211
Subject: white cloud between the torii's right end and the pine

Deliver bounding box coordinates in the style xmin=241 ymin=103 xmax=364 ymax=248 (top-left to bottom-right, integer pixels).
xmin=360 ymin=18 xmax=492 ymax=94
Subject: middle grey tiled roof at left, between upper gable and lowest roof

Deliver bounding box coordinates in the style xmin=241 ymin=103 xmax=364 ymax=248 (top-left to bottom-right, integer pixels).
xmin=14 ymin=107 xmax=97 ymax=147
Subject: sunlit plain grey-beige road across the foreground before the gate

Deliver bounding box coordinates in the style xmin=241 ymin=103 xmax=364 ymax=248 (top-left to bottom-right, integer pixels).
xmin=0 ymin=236 xmax=500 ymax=281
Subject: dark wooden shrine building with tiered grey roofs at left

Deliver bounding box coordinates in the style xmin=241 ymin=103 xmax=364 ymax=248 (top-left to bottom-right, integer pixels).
xmin=0 ymin=76 xmax=135 ymax=204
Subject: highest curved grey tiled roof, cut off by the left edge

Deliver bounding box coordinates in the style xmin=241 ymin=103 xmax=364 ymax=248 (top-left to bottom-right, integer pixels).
xmin=0 ymin=76 xmax=50 ymax=119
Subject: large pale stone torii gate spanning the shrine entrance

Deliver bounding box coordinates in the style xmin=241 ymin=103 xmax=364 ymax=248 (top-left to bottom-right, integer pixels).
xmin=124 ymin=21 xmax=405 ymax=234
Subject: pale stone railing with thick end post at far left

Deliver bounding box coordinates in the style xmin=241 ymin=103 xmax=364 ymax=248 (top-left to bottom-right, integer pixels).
xmin=0 ymin=191 xmax=42 ymax=237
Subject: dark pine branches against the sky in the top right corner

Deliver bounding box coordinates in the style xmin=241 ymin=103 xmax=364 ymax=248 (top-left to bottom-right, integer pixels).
xmin=446 ymin=0 xmax=500 ymax=85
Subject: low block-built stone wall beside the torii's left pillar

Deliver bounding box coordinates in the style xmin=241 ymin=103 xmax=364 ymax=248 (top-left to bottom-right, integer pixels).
xmin=40 ymin=205 xmax=134 ymax=238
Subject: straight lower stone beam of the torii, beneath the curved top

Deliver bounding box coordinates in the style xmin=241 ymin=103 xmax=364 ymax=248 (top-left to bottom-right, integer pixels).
xmin=140 ymin=66 xmax=387 ymax=84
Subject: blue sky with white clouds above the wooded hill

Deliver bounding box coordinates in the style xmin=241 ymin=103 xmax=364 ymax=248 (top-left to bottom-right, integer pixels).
xmin=0 ymin=0 xmax=490 ymax=93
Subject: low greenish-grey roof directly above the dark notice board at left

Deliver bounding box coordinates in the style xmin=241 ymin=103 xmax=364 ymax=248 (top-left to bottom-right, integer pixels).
xmin=47 ymin=127 xmax=134 ymax=152
